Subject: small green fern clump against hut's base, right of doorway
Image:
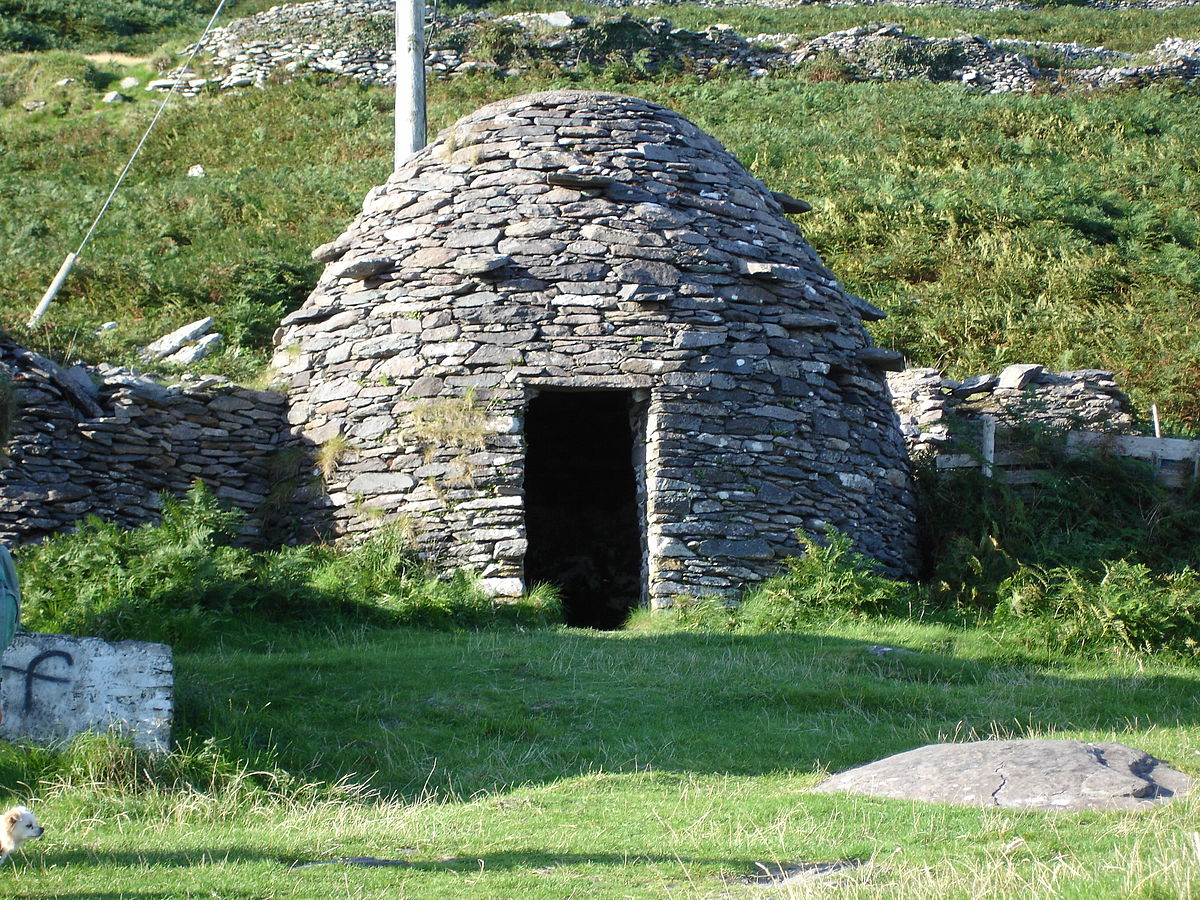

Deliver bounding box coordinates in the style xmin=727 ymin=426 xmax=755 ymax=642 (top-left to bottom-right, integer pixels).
xmin=738 ymin=528 xmax=916 ymax=631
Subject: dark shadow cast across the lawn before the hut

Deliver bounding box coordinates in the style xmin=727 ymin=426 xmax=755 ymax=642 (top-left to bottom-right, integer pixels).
xmin=178 ymin=630 xmax=1200 ymax=798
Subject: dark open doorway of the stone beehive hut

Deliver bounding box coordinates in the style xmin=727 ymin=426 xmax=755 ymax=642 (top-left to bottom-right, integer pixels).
xmin=524 ymin=390 xmax=642 ymax=629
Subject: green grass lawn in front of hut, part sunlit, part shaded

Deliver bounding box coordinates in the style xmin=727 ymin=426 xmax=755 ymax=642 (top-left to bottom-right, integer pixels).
xmin=0 ymin=622 xmax=1200 ymax=899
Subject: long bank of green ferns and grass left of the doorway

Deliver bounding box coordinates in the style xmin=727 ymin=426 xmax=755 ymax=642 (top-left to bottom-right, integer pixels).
xmin=18 ymin=482 xmax=562 ymax=649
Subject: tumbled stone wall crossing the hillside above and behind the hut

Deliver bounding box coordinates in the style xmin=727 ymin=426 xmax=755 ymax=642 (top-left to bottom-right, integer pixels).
xmin=146 ymin=0 xmax=1200 ymax=95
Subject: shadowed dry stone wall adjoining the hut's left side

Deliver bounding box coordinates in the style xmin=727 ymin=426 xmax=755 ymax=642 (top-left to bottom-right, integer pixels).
xmin=0 ymin=341 xmax=287 ymax=544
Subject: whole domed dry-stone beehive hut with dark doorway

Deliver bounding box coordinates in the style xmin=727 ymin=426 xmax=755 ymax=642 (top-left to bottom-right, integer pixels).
xmin=276 ymin=91 xmax=914 ymax=626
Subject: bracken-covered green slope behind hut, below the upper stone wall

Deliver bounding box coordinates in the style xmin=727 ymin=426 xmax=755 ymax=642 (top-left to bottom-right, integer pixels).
xmin=0 ymin=55 xmax=1200 ymax=428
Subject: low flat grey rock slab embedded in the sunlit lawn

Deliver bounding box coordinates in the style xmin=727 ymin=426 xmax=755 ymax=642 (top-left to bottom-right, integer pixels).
xmin=814 ymin=740 xmax=1193 ymax=810
